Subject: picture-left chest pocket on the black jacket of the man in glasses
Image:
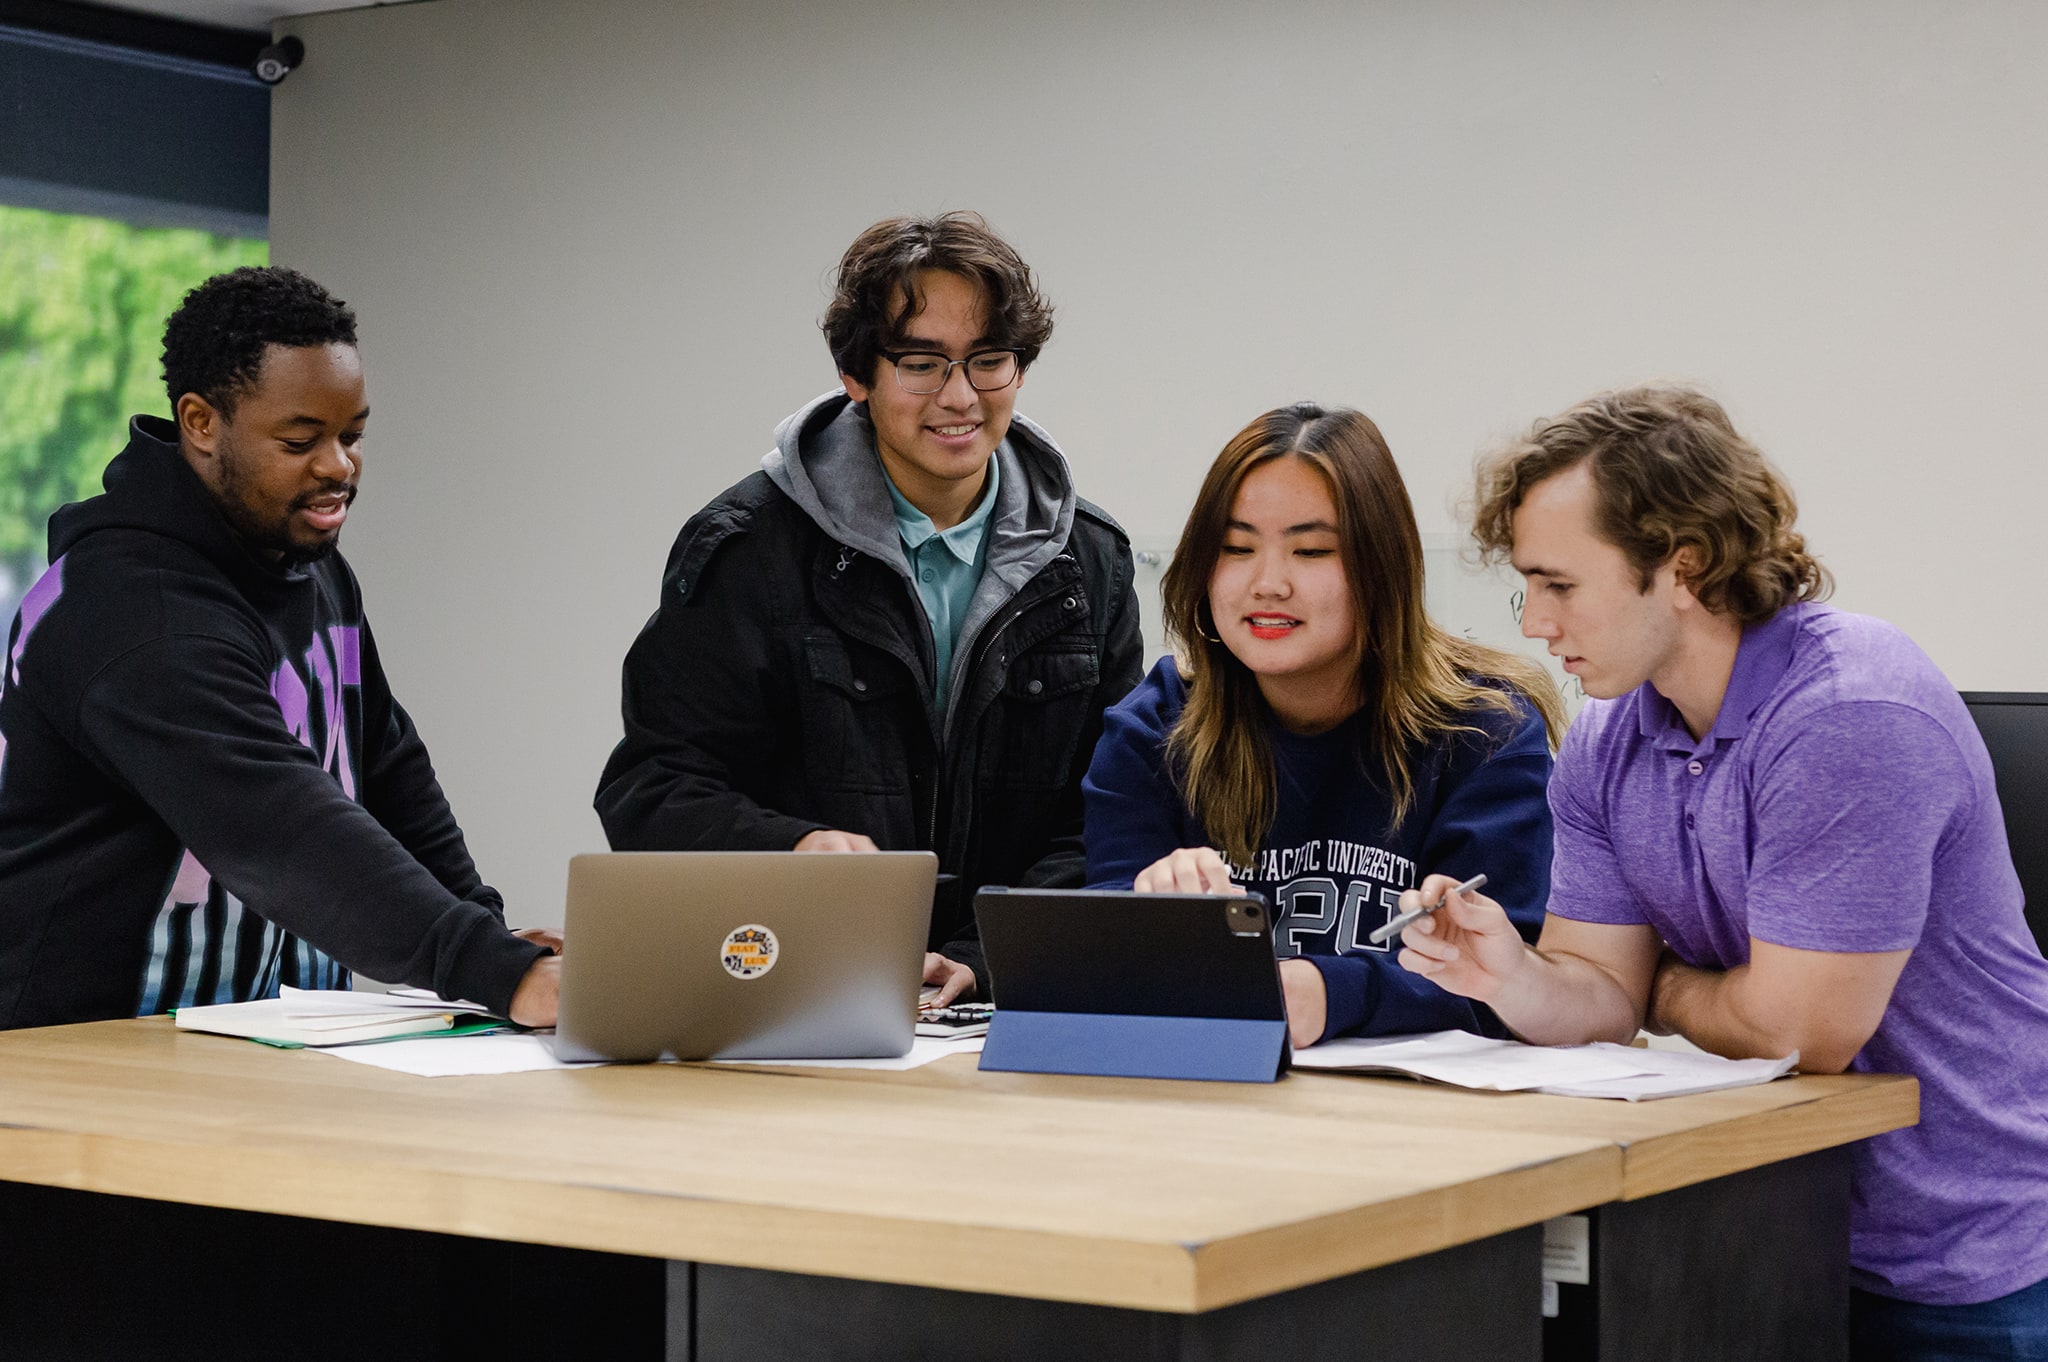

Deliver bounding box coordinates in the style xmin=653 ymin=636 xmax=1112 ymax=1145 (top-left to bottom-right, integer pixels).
xmin=803 ymin=629 xmax=909 ymax=795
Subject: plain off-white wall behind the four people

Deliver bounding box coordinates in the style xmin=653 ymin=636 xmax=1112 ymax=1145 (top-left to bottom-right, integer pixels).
xmin=270 ymin=0 xmax=2048 ymax=922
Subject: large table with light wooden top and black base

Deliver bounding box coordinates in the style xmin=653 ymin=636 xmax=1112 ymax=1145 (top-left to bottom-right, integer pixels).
xmin=0 ymin=1018 xmax=1917 ymax=1362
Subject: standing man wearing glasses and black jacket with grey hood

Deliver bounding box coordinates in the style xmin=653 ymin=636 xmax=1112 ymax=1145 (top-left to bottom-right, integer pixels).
xmin=596 ymin=213 xmax=1141 ymax=1002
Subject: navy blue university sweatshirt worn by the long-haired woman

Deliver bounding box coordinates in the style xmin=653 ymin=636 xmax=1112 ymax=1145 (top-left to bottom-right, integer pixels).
xmin=1081 ymin=657 xmax=1550 ymax=1038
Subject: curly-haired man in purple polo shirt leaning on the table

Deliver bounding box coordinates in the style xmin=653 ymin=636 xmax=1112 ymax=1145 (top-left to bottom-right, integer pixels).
xmin=1399 ymin=389 xmax=2048 ymax=1360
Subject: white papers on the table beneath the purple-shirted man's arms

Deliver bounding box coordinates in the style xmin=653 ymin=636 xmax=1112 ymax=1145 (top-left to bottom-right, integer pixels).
xmin=1294 ymin=1030 xmax=1798 ymax=1102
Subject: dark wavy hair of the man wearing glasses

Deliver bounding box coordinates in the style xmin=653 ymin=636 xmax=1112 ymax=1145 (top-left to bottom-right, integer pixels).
xmin=821 ymin=213 xmax=1053 ymax=385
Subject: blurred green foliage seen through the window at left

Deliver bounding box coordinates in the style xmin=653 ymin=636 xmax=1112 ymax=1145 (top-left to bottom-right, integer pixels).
xmin=0 ymin=205 xmax=270 ymax=598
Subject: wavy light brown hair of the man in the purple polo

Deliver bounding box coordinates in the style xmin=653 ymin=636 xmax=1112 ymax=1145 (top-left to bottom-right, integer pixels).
xmin=1473 ymin=385 xmax=1835 ymax=623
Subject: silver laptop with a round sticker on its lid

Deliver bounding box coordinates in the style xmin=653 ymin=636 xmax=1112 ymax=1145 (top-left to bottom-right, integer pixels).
xmin=555 ymin=852 xmax=938 ymax=1059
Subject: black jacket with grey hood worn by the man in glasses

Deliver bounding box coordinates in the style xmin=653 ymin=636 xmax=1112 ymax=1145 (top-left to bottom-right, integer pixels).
xmin=596 ymin=387 xmax=1143 ymax=993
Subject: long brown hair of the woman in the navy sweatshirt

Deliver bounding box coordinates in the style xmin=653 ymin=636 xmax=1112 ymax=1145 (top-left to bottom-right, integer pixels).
xmin=1161 ymin=401 xmax=1565 ymax=866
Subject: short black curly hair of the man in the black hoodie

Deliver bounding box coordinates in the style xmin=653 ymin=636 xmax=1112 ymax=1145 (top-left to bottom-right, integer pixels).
xmin=164 ymin=264 xmax=356 ymax=416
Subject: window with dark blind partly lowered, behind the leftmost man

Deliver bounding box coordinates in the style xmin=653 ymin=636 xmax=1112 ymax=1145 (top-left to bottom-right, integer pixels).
xmin=0 ymin=14 xmax=270 ymax=621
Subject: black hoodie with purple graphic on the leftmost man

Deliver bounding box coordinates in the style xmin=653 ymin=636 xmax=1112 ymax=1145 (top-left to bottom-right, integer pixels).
xmin=0 ymin=416 xmax=541 ymax=1026
